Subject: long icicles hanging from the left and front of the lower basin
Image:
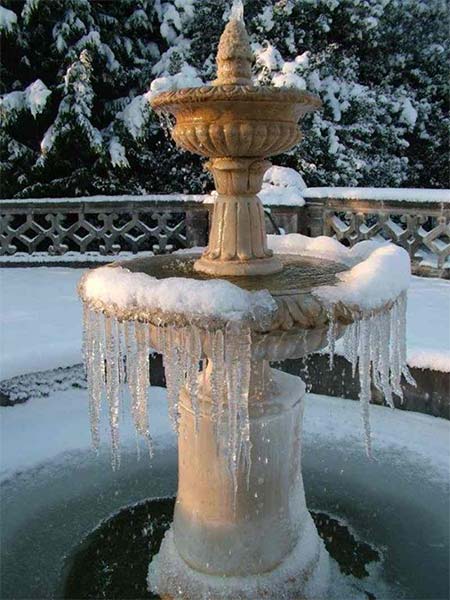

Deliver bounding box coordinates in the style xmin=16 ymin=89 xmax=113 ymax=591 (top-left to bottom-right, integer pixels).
xmin=83 ymin=305 xmax=251 ymax=479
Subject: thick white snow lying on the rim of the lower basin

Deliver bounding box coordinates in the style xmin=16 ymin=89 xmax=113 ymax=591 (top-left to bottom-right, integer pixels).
xmin=79 ymin=234 xmax=411 ymax=320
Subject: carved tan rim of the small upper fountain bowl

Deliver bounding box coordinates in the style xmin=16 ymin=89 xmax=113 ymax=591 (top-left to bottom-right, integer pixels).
xmin=150 ymin=85 xmax=322 ymax=112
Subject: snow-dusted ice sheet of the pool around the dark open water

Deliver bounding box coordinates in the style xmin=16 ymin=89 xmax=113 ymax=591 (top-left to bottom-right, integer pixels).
xmin=0 ymin=388 xmax=450 ymax=600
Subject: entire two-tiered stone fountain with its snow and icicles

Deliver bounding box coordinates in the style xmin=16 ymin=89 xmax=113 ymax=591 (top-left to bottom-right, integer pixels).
xmin=79 ymin=6 xmax=409 ymax=600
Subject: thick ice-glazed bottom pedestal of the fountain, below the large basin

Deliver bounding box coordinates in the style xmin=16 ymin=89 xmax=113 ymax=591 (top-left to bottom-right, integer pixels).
xmin=149 ymin=368 xmax=328 ymax=600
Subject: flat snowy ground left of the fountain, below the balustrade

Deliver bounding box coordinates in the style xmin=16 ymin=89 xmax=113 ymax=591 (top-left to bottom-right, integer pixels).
xmin=0 ymin=267 xmax=85 ymax=380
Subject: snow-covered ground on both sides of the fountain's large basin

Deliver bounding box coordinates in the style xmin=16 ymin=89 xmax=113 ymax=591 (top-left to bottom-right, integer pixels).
xmin=0 ymin=267 xmax=450 ymax=380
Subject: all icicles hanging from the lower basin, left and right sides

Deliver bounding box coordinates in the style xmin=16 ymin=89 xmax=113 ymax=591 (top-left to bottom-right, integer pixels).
xmin=83 ymin=294 xmax=414 ymax=481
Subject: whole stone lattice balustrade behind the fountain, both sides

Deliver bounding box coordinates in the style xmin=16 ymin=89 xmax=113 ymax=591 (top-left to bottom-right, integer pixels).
xmin=0 ymin=188 xmax=450 ymax=277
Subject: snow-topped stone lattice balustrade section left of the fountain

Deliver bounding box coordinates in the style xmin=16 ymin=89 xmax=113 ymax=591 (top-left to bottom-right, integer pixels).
xmin=0 ymin=194 xmax=208 ymax=259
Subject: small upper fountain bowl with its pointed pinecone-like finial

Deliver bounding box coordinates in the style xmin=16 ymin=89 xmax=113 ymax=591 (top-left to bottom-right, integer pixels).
xmin=151 ymin=18 xmax=321 ymax=158
